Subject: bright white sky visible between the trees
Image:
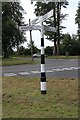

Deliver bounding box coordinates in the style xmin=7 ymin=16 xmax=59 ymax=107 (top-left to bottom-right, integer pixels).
xmin=21 ymin=0 xmax=79 ymax=49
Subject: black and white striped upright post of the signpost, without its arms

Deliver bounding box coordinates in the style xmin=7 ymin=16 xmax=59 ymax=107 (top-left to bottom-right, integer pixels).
xmin=41 ymin=19 xmax=46 ymax=94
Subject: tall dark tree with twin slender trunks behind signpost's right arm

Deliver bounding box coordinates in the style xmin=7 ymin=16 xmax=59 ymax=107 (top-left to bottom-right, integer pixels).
xmin=35 ymin=2 xmax=68 ymax=55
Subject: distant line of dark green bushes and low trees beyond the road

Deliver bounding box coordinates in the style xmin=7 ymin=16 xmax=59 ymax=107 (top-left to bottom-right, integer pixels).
xmin=13 ymin=34 xmax=80 ymax=56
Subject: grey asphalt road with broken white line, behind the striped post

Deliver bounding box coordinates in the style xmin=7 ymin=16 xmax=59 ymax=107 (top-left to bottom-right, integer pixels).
xmin=2 ymin=59 xmax=80 ymax=78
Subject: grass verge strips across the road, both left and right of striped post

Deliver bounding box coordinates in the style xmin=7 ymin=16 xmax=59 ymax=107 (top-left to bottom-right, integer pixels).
xmin=0 ymin=56 xmax=80 ymax=66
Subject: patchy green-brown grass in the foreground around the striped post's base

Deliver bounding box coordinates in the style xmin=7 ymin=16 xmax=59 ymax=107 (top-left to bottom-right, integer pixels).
xmin=2 ymin=77 xmax=78 ymax=118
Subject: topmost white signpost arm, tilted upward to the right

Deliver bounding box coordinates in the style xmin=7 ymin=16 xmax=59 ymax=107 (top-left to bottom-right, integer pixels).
xmin=31 ymin=10 xmax=53 ymax=25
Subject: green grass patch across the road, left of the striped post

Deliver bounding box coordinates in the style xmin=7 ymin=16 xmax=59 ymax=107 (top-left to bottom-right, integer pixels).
xmin=0 ymin=58 xmax=38 ymax=66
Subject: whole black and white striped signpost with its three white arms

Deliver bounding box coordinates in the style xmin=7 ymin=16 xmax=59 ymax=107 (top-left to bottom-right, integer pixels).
xmin=20 ymin=10 xmax=56 ymax=94
